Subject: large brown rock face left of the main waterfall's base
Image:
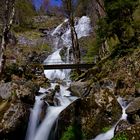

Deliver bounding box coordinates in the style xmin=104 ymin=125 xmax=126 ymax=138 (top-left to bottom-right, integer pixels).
xmin=0 ymin=79 xmax=38 ymax=140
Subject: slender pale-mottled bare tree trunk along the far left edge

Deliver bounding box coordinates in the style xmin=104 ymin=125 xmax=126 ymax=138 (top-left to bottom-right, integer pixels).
xmin=0 ymin=0 xmax=15 ymax=76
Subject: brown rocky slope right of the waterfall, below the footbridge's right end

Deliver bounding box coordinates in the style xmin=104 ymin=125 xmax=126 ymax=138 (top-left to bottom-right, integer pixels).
xmin=59 ymin=48 xmax=140 ymax=140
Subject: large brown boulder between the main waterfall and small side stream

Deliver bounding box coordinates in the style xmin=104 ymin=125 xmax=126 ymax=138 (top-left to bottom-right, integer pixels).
xmin=59 ymin=79 xmax=121 ymax=139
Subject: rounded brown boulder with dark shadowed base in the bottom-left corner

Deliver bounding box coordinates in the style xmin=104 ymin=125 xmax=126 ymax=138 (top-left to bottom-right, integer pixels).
xmin=0 ymin=102 xmax=29 ymax=140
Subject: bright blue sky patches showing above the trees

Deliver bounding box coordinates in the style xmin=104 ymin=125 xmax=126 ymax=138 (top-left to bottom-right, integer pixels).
xmin=33 ymin=0 xmax=61 ymax=9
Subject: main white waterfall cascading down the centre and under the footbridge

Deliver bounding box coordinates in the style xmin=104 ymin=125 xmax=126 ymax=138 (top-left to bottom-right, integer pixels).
xmin=26 ymin=16 xmax=91 ymax=140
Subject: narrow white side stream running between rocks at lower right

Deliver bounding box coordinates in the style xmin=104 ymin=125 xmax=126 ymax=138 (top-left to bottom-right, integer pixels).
xmin=93 ymin=97 xmax=127 ymax=140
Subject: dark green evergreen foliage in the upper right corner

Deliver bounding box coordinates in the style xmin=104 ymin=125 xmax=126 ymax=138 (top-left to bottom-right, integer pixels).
xmin=97 ymin=0 xmax=138 ymax=54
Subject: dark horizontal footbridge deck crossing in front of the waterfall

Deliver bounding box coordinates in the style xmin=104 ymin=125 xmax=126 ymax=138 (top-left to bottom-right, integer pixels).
xmin=43 ymin=63 xmax=95 ymax=70
